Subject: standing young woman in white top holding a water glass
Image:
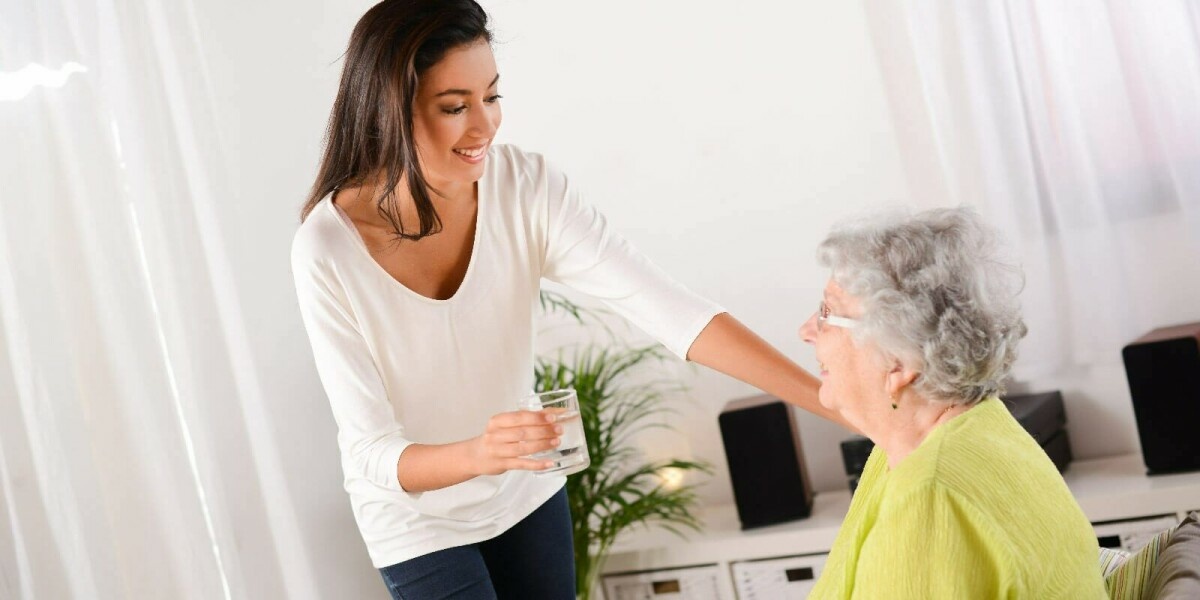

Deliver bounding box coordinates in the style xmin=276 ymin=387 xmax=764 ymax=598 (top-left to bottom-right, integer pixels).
xmin=292 ymin=0 xmax=832 ymax=599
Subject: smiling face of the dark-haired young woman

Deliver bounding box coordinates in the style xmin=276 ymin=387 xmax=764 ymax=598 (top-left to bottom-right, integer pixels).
xmin=413 ymin=40 xmax=500 ymax=193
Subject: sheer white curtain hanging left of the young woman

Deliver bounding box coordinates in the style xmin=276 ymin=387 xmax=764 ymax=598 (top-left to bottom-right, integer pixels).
xmin=0 ymin=0 xmax=316 ymax=599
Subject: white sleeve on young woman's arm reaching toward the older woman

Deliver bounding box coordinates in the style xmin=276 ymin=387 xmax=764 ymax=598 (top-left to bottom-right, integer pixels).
xmin=542 ymin=157 xmax=725 ymax=359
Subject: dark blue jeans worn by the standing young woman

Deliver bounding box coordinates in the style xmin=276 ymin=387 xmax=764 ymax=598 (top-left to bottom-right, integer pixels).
xmin=379 ymin=487 xmax=575 ymax=600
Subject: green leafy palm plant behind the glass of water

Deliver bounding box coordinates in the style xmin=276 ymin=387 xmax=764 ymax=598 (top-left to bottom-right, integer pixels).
xmin=535 ymin=292 xmax=712 ymax=600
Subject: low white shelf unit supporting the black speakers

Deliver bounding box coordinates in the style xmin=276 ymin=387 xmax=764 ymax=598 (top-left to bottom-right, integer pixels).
xmin=601 ymin=455 xmax=1200 ymax=600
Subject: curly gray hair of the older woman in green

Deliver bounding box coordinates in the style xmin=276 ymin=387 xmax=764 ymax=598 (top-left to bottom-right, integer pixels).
xmin=817 ymin=208 xmax=1027 ymax=404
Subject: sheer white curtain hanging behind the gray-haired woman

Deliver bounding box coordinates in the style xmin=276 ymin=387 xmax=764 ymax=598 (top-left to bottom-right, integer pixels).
xmin=868 ymin=0 xmax=1200 ymax=377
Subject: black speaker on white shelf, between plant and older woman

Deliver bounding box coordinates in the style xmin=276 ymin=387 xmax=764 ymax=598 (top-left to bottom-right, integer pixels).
xmin=718 ymin=396 xmax=812 ymax=529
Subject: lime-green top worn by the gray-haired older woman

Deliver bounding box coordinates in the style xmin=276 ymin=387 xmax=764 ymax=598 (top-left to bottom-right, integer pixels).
xmin=809 ymin=398 xmax=1108 ymax=599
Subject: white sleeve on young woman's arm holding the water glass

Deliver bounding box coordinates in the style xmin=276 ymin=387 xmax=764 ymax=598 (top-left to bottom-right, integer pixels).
xmin=292 ymin=247 xmax=420 ymax=500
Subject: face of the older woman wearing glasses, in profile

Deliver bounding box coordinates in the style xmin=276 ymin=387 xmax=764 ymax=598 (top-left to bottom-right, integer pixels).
xmin=800 ymin=278 xmax=886 ymax=413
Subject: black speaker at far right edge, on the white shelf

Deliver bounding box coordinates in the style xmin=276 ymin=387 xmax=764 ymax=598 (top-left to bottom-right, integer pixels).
xmin=1121 ymin=323 xmax=1200 ymax=475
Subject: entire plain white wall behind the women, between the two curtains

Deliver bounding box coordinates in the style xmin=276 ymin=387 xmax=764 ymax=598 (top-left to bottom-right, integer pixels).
xmin=182 ymin=0 xmax=1192 ymax=590
